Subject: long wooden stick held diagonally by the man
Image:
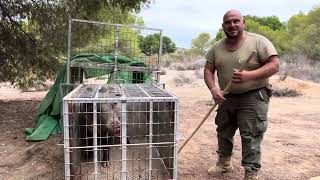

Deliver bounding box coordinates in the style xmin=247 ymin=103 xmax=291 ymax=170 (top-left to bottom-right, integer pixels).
xmin=178 ymin=50 xmax=257 ymax=153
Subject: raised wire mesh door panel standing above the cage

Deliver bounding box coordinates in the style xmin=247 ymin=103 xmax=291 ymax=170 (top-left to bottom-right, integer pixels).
xmin=67 ymin=19 xmax=162 ymax=84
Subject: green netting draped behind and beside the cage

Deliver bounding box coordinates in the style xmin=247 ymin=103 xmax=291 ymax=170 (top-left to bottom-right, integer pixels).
xmin=25 ymin=53 xmax=153 ymax=141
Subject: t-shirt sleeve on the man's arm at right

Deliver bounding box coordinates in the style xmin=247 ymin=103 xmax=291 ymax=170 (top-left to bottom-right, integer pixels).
xmin=257 ymin=36 xmax=278 ymax=62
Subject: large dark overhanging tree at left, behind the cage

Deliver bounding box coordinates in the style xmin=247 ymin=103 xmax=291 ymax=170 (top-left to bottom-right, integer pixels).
xmin=0 ymin=0 xmax=150 ymax=87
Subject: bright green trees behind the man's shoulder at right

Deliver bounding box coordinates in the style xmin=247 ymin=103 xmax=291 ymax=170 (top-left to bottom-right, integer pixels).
xmin=215 ymin=7 xmax=320 ymax=60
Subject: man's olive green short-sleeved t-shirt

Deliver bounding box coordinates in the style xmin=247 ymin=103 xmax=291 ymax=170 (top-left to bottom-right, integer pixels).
xmin=205 ymin=32 xmax=278 ymax=93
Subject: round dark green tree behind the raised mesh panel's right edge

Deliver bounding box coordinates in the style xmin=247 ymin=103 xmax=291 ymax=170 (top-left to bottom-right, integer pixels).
xmin=139 ymin=33 xmax=176 ymax=55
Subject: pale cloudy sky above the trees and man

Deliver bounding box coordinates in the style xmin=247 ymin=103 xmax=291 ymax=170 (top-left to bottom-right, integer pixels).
xmin=139 ymin=0 xmax=320 ymax=48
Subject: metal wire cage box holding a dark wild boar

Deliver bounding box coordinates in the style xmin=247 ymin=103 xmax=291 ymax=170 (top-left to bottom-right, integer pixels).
xmin=63 ymin=84 xmax=178 ymax=180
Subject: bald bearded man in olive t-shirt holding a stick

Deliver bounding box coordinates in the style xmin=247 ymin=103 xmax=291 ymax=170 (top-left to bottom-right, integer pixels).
xmin=204 ymin=10 xmax=279 ymax=180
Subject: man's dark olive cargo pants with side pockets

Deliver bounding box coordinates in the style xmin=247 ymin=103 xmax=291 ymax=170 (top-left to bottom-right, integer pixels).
xmin=215 ymin=88 xmax=270 ymax=172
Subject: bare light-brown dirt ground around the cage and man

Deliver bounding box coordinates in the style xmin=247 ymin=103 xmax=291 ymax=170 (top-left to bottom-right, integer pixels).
xmin=0 ymin=70 xmax=320 ymax=180
